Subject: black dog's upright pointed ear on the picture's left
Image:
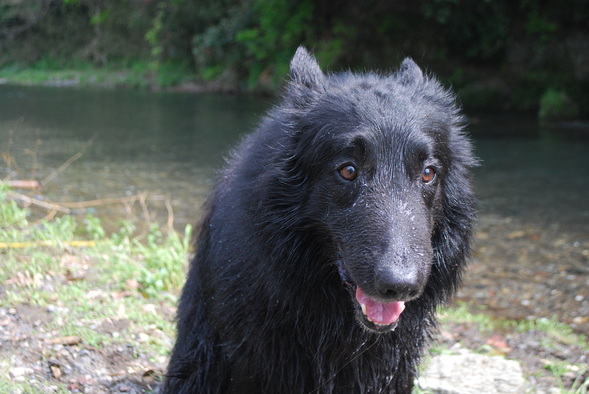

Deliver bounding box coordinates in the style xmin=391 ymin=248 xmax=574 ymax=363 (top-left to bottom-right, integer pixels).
xmin=289 ymin=46 xmax=327 ymax=94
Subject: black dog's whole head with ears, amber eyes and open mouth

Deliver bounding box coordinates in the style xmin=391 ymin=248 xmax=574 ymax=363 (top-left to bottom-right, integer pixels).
xmin=264 ymin=48 xmax=475 ymax=332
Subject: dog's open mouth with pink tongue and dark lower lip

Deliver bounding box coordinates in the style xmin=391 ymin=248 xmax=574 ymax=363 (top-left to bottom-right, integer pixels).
xmin=339 ymin=262 xmax=405 ymax=333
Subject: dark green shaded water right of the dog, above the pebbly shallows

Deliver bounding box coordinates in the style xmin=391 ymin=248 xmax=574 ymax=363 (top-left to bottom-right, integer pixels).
xmin=470 ymin=115 xmax=589 ymax=238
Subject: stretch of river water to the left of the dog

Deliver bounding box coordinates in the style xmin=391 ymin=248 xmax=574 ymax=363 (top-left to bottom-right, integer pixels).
xmin=0 ymin=86 xmax=269 ymax=228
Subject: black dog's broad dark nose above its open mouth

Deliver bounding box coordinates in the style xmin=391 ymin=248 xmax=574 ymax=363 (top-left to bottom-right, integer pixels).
xmin=374 ymin=272 xmax=423 ymax=301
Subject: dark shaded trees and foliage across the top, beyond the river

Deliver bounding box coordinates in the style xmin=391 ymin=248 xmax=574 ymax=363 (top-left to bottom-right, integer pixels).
xmin=0 ymin=0 xmax=589 ymax=119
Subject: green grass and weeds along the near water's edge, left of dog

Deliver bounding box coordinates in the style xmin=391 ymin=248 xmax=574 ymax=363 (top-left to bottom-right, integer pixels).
xmin=0 ymin=184 xmax=192 ymax=302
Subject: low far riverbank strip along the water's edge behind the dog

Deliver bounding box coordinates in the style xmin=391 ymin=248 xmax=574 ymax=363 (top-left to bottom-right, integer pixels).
xmin=0 ymin=61 xmax=589 ymax=121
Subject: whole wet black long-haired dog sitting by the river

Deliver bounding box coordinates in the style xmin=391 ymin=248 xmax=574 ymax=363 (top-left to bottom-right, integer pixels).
xmin=164 ymin=48 xmax=475 ymax=394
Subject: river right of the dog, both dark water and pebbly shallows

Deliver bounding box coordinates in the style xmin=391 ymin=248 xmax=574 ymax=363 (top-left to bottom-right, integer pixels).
xmin=457 ymin=116 xmax=589 ymax=334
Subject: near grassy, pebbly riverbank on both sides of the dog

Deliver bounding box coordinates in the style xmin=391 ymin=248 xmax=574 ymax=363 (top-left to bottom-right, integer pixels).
xmin=0 ymin=187 xmax=589 ymax=393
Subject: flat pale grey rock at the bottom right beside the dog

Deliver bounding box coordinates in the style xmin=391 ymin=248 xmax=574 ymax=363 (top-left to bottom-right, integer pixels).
xmin=418 ymin=351 xmax=526 ymax=394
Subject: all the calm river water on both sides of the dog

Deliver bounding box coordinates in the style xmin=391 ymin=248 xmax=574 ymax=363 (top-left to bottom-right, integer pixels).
xmin=0 ymin=85 xmax=589 ymax=333
